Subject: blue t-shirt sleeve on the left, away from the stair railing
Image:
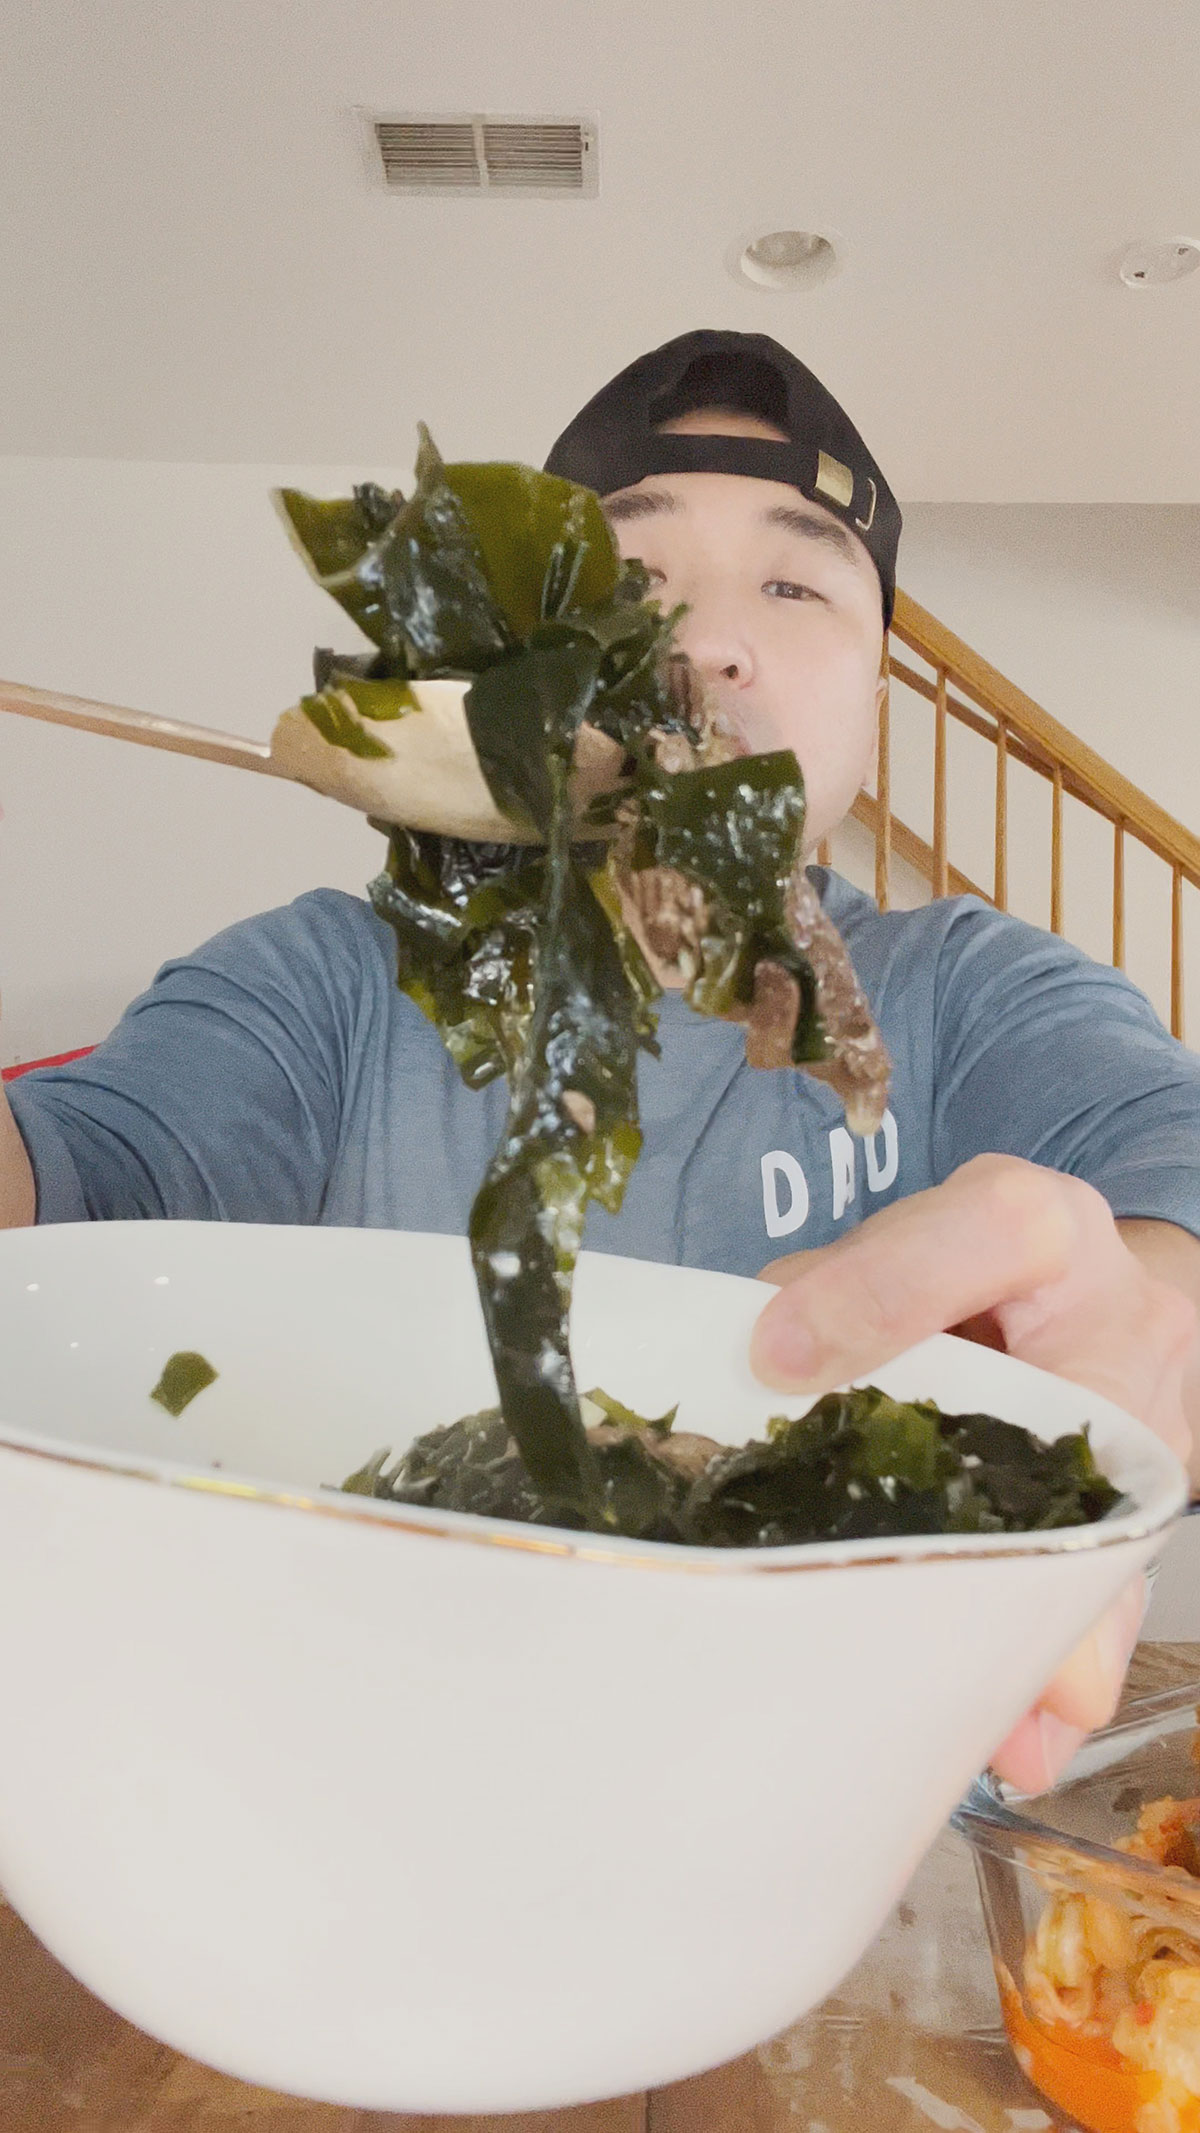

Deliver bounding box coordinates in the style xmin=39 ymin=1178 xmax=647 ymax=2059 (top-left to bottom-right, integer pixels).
xmin=11 ymin=894 xmax=373 ymax=1222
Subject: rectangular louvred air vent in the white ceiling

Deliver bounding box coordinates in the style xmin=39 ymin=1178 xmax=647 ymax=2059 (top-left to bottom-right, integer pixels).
xmin=364 ymin=113 xmax=599 ymax=201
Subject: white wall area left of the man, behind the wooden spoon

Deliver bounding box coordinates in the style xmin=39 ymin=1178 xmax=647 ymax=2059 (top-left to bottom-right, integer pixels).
xmin=0 ymin=459 xmax=386 ymax=1064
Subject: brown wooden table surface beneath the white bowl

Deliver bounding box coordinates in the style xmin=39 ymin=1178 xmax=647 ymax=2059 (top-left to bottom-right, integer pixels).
xmin=0 ymin=1645 xmax=1200 ymax=2133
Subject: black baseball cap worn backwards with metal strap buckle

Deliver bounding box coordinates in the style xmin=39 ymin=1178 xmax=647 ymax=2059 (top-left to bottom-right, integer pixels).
xmin=546 ymin=331 xmax=902 ymax=627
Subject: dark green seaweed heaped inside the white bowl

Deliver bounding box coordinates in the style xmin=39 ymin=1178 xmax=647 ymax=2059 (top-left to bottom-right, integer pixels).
xmin=341 ymin=1386 xmax=1123 ymax=1549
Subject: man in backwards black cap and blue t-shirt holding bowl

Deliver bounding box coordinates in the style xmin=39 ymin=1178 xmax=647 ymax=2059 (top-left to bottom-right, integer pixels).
xmin=0 ymin=333 xmax=1200 ymax=1790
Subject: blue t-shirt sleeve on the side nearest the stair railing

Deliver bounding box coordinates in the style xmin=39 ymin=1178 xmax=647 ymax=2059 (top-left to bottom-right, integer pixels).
xmin=934 ymin=900 xmax=1200 ymax=1237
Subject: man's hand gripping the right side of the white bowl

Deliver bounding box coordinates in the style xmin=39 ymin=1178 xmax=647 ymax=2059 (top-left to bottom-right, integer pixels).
xmin=752 ymin=1156 xmax=1196 ymax=1792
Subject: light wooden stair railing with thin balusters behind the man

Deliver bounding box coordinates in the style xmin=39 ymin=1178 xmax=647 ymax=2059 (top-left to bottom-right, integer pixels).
xmin=821 ymin=593 xmax=1200 ymax=1037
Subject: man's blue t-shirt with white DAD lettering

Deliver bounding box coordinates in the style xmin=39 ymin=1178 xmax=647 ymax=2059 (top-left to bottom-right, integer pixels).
xmin=11 ymin=868 xmax=1200 ymax=1273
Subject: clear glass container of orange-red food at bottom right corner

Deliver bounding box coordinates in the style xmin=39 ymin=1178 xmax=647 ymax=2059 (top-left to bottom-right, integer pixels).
xmin=953 ymin=1679 xmax=1200 ymax=2133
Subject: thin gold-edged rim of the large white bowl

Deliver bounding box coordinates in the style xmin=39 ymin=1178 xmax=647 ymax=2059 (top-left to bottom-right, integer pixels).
xmin=0 ymin=1220 xmax=1187 ymax=1576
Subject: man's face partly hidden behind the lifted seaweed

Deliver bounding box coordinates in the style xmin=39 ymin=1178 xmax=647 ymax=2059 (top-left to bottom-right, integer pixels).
xmin=605 ymin=410 xmax=882 ymax=851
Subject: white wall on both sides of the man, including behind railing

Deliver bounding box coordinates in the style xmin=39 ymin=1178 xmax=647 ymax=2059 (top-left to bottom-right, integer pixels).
xmin=0 ymin=459 xmax=1200 ymax=1064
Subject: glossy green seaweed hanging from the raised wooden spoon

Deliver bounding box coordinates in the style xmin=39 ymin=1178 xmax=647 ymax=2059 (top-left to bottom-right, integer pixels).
xmin=279 ymin=429 xmax=890 ymax=1527
